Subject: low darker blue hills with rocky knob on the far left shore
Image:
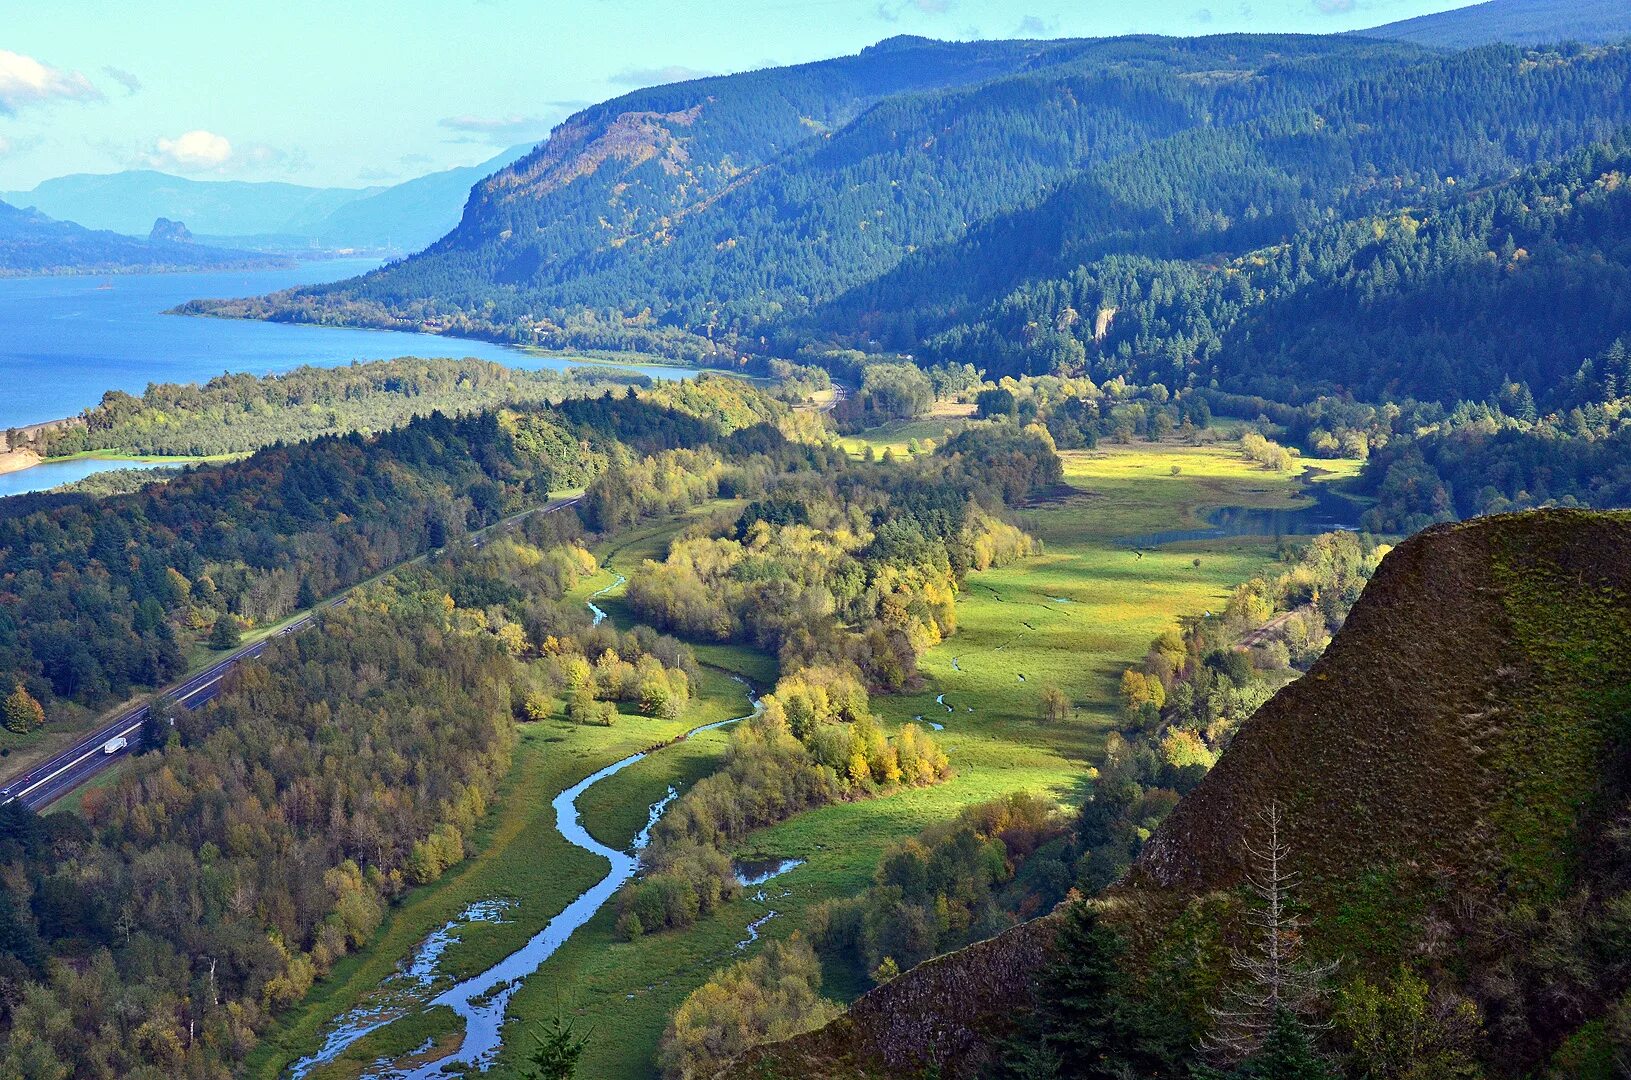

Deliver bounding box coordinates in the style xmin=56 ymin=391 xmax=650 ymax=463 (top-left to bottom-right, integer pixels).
xmin=0 ymin=202 xmax=287 ymax=277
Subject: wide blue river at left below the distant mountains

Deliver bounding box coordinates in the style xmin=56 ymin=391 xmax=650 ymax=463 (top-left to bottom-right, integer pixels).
xmin=0 ymin=259 xmax=695 ymax=430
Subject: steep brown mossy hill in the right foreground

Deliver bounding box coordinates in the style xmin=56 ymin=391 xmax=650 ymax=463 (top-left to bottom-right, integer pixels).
xmin=729 ymin=511 xmax=1631 ymax=1080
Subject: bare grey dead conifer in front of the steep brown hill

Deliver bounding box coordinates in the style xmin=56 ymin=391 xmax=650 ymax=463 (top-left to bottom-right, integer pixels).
xmin=1200 ymin=803 xmax=1336 ymax=1065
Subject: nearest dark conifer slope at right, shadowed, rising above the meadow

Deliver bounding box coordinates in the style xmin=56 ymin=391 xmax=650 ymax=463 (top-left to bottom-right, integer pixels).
xmin=925 ymin=139 xmax=1631 ymax=406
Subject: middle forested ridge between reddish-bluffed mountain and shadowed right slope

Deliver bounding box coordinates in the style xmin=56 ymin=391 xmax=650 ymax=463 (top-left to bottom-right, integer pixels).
xmin=848 ymin=47 xmax=1631 ymax=374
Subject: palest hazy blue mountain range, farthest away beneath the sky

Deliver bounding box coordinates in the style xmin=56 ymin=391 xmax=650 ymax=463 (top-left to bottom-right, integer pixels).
xmin=0 ymin=147 xmax=530 ymax=251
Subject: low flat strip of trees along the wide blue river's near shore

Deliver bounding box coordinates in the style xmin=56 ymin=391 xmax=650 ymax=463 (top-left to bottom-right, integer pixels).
xmin=8 ymin=357 xmax=651 ymax=457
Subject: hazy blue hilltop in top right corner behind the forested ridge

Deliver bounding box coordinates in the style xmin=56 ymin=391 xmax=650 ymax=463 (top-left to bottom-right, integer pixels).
xmin=1359 ymin=0 xmax=1631 ymax=49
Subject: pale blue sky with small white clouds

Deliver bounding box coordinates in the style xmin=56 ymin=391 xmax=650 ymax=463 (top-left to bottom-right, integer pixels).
xmin=0 ymin=0 xmax=1487 ymax=191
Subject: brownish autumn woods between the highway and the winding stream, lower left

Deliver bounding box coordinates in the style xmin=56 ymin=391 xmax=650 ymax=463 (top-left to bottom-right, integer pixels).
xmin=0 ymin=607 xmax=514 ymax=1080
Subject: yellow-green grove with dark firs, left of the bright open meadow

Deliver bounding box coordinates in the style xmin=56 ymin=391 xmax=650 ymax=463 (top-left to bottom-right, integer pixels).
xmin=628 ymin=429 xmax=1060 ymax=690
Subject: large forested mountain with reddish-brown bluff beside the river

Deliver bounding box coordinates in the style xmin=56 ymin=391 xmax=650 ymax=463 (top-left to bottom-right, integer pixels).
xmin=190 ymin=36 xmax=1416 ymax=352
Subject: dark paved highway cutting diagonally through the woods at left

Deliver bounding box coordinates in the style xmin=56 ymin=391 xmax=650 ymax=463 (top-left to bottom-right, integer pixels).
xmin=0 ymin=496 xmax=582 ymax=809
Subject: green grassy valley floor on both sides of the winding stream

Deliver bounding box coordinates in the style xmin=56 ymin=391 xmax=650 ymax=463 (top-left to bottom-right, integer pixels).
xmin=251 ymin=437 xmax=1354 ymax=1078
